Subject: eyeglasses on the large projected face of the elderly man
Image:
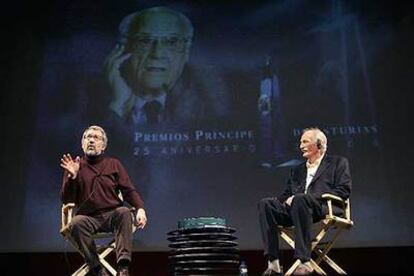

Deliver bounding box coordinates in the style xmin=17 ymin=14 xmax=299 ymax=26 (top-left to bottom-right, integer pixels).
xmin=131 ymin=36 xmax=191 ymax=53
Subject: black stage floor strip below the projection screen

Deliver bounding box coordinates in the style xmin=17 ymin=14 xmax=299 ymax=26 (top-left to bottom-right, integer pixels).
xmin=0 ymin=247 xmax=414 ymax=276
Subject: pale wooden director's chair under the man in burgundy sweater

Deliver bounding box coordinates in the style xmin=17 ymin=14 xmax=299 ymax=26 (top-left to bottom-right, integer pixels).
xmin=60 ymin=203 xmax=137 ymax=276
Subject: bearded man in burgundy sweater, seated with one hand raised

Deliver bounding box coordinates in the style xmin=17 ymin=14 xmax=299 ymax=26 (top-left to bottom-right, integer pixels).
xmin=60 ymin=126 xmax=147 ymax=276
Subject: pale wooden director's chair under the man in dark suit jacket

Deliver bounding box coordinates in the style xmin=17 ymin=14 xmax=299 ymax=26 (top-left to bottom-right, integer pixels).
xmin=279 ymin=194 xmax=354 ymax=275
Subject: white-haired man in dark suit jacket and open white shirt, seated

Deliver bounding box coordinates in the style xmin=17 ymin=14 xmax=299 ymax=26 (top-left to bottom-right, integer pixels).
xmin=259 ymin=128 xmax=352 ymax=275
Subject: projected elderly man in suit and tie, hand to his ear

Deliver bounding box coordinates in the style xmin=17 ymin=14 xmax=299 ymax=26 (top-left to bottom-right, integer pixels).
xmin=105 ymin=7 xmax=227 ymax=125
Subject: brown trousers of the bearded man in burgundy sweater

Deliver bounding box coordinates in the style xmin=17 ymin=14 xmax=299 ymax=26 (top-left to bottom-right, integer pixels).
xmin=69 ymin=207 xmax=133 ymax=267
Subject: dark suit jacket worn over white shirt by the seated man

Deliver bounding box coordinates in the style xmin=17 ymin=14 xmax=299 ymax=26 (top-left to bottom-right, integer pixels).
xmin=278 ymin=155 xmax=352 ymax=202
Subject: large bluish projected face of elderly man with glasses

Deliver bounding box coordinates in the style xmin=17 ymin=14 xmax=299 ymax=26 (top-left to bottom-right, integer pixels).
xmin=126 ymin=8 xmax=193 ymax=95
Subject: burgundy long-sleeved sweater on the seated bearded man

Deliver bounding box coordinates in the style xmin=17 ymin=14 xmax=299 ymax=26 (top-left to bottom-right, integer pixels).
xmin=60 ymin=155 xmax=144 ymax=215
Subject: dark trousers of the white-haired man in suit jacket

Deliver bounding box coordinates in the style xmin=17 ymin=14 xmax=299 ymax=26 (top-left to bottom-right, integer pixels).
xmin=259 ymin=194 xmax=325 ymax=262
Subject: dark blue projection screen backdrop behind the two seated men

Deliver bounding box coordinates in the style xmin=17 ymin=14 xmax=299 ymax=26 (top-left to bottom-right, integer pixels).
xmin=0 ymin=1 xmax=414 ymax=252
